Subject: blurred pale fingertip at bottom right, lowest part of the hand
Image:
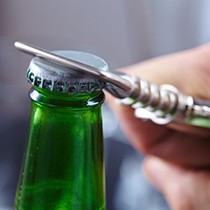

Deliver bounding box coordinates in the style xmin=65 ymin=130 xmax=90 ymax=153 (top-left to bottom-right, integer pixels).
xmin=143 ymin=157 xmax=210 ymax=210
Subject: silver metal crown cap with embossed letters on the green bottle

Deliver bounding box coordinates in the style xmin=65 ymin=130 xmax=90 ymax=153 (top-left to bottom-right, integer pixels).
xmin=27 ymin=51 xmax=108 ymax=94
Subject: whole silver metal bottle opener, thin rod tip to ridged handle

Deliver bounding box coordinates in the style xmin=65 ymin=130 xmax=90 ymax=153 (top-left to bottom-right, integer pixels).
xmin=14 ymin=42 xmax=210 ymax=128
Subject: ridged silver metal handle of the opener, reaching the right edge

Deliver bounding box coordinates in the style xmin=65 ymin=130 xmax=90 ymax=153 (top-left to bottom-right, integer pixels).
xmin=118 ymin=77 xmax=210 ymax=128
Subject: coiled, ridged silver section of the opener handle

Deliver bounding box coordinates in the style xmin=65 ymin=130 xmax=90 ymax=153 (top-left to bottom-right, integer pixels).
xmin=116 ymin=77 xmax=193 ymax=125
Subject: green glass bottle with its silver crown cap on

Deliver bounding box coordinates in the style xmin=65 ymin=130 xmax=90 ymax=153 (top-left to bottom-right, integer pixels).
xmin=15 ymin=51 xmax=108 ymax=210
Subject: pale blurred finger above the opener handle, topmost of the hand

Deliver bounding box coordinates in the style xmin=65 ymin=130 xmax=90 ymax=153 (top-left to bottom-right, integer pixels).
xmin=121 ymin=44 xmax=210 ymax=99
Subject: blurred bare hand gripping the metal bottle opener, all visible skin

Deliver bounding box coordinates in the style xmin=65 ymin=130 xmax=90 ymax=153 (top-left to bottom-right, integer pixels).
xmin=107 ymin=44 xmax=210 ymax=210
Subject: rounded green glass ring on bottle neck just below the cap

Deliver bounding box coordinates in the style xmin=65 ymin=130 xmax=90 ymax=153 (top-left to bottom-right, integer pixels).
xmin=29 ymin=87 xmax=104 ymax=108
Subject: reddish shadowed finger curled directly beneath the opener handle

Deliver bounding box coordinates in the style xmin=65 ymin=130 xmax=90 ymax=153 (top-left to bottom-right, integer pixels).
xmin=108 ymin=94 xmax=210 ymax=167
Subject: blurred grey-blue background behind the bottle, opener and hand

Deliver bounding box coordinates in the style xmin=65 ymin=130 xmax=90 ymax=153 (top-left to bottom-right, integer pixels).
xmin=0 ymin=0 xmax=210 ymax=210
